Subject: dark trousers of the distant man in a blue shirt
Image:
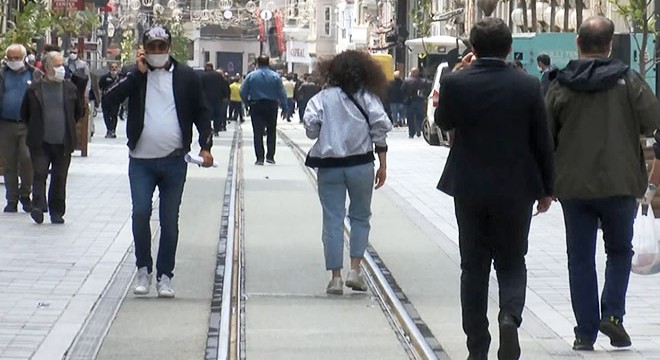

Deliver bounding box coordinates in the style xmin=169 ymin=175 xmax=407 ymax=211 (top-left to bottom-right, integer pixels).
xmin=250 ymin=100 xmax=277 ymax=160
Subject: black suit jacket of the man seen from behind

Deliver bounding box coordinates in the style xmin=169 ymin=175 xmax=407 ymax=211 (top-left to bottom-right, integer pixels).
xmin=435 ymin=59 xmax=554 ymax=200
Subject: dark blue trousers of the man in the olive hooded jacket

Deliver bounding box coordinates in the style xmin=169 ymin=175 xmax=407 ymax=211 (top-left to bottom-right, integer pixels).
xmin=561 ymin=196 xmax=637 ymax=341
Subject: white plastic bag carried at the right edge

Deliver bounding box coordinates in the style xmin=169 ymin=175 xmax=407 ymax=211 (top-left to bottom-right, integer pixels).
xmin=632 ymin=206 xmax=660 ymax=275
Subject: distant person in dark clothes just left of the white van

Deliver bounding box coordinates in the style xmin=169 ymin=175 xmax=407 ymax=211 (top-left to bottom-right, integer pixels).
xmin=401 ymin=68 xmax=431 ymax=139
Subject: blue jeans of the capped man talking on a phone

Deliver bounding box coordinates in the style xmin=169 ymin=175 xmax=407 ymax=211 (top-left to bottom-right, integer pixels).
xmin=128 ymin=155 xmax=188 ymax=279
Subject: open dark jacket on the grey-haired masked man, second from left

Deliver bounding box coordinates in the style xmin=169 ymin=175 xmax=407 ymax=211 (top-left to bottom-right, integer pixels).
xmin=21 ymin=80 xmax=84 ymax=153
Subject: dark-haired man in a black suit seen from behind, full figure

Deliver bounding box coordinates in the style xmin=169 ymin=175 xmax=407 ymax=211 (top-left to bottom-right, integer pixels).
xmin=435 ymin=18 xmax=554 ymax=360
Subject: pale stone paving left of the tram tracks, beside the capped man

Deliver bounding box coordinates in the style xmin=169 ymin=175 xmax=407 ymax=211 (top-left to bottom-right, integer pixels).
xmin=0 ymin=118 xmax=132 ymax=359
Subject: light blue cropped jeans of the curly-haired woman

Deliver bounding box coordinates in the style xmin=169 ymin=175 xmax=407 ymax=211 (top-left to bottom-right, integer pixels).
xmin=318 ymin=163 xmax=375 ymax=270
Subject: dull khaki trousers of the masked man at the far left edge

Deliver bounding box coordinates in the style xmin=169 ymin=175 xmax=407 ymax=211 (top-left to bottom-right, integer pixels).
xmin=0 ymin=120 xmax=33 ymax=202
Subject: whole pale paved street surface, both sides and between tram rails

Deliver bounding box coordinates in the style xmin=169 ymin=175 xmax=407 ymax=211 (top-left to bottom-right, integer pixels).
xmin=0 ymin=116 xmax=660 ymax=360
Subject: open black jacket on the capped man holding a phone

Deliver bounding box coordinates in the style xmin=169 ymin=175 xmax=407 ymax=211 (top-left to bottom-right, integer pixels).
xmin=103 ymin=58 xmax=213 ymax=152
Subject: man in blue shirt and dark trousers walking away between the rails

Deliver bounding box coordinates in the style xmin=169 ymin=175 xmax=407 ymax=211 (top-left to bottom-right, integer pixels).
xmin=241 ymin=55 xmax=289 ymax=165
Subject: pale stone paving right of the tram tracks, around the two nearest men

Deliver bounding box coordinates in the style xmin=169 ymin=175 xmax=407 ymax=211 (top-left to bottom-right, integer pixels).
xmin=286 ymin=125 xmax=660 ymax=359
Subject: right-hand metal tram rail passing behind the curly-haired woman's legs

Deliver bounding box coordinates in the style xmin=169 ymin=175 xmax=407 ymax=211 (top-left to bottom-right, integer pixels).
xmin=278 ymin=130 xmax=449 ymax=360
